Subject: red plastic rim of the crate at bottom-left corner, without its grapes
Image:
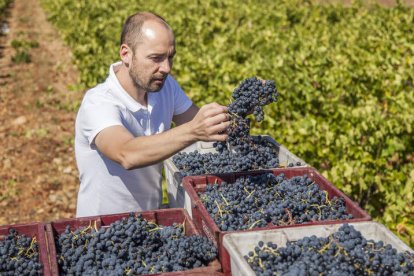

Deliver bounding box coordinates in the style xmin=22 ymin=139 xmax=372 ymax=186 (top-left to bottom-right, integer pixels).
xmin=0 ymin=223 xmax=52 ymax=276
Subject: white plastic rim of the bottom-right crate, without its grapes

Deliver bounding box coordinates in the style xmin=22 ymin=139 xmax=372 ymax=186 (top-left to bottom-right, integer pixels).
xmin=223 ymin=222 xmax=414 ymax=276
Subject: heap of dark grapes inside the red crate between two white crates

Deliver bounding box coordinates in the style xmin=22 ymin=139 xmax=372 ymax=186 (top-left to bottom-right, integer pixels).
xmin=199 ymin=173 xmax=352 ymax=231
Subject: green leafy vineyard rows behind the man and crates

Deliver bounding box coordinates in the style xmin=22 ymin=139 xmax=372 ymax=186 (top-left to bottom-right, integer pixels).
xmin=42 ymin=0 xmax=414 ymax=246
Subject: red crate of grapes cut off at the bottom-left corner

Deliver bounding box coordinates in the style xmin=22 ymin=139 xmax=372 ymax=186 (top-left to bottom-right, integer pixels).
xmin=0 ymin=223 xmax=52 ymax=275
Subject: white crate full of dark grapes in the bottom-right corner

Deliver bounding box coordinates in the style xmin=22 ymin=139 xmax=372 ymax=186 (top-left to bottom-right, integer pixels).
xmin=223 ymin=222 xmax=414 ymax=276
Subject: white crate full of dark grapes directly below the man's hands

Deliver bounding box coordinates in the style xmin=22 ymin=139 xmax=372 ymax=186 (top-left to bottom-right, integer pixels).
xmin=164 ymin=135 xmax=308 ymax=210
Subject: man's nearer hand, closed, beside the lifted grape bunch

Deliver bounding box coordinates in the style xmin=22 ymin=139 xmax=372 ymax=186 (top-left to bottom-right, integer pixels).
xmin=189 ymin=103 xmax=230 ymax=141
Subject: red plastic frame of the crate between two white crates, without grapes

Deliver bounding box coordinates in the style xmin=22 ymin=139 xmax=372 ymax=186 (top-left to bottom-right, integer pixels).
xmin=183 ymin=168 xmax=371 ymax=272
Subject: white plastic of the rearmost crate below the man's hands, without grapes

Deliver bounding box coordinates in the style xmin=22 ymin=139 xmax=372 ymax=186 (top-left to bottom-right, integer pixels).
xmin=164 ymin=135 xmax=308 ymax=211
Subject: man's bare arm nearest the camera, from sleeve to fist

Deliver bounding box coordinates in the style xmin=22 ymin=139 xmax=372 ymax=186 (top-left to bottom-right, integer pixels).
xmin=95 ymin=103 xmax=229 ymax=170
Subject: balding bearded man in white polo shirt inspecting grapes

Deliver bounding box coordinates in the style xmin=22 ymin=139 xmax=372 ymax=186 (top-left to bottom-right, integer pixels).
xmin=75 ymin=12 xmax=229 ymax=217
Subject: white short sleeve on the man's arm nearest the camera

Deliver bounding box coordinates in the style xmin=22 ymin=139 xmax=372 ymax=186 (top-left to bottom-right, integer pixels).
xmin=77 ymin=102 xmax=123 ymax=145
